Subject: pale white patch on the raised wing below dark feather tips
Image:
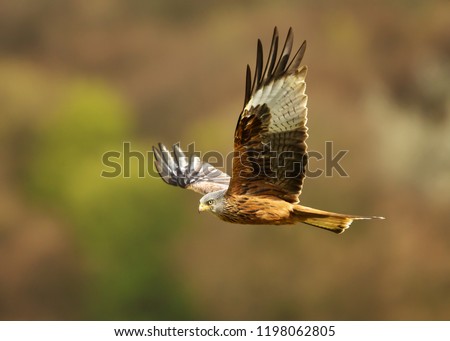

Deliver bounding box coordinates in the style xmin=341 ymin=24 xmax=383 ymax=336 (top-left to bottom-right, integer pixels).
xmin=244 ymin=66 xmax=308 ymax=133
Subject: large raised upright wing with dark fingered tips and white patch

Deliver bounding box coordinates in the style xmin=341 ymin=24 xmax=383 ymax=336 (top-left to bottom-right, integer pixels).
xmin=227 ymin=27 xmax=308 ymax=203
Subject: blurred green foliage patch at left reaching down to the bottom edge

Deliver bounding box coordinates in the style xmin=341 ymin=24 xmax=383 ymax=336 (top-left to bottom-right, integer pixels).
xmin=19 ymin=81 xmax=195 ymax=320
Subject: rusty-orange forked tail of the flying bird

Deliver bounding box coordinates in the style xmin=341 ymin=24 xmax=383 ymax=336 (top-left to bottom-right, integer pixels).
xmin=294 ymin=205 xmax=384 ymax=234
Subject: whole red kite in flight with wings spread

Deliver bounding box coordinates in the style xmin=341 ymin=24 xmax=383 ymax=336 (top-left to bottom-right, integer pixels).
xmin=153 ymin=27 xmax=383 ymax=233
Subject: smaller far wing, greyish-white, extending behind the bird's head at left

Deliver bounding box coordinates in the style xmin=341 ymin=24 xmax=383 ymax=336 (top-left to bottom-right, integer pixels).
xmin=153 ymin=143 xmax=230 ymax=194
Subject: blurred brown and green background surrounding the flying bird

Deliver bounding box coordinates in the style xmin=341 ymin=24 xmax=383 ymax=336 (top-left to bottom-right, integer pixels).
xmin=0 ymin=0 xmax=450 ymax=320
